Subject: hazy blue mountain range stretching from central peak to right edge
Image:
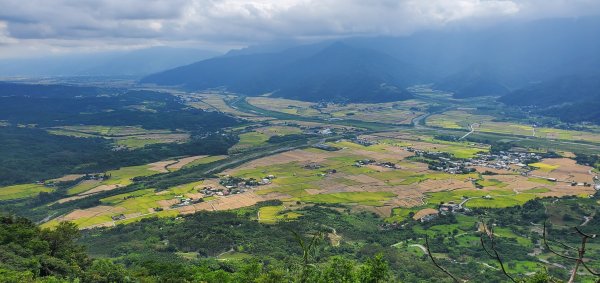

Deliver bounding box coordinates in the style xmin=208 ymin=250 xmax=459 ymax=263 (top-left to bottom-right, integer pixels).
xmin=142 ymin=17 xmax=600 ymax=106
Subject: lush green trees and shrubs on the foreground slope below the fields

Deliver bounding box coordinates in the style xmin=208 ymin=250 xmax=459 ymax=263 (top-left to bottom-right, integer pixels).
xmin=0 ymin=196 xmax=600 ymax=282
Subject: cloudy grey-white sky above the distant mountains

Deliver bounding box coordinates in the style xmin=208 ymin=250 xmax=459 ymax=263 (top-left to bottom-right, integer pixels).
xmin=0 ymin=0 xmax=600 ymax=58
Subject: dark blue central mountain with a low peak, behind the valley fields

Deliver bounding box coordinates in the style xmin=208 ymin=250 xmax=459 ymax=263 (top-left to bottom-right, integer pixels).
xmin=141 ymin=42 xmax=422 ymax=102
